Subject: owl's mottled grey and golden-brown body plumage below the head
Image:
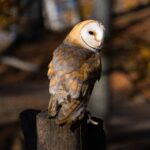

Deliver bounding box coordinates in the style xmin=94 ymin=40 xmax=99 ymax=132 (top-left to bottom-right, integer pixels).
xmin=48 ymin=45 xmax=101 ymax=124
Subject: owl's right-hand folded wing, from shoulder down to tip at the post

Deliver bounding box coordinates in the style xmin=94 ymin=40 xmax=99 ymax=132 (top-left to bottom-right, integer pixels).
xmin=57 ymin=57 xmax=101 ymax=124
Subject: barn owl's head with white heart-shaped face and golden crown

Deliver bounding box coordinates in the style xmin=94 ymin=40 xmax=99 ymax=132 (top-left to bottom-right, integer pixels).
xmin=65 ymin=20 xmax=104 ymax=52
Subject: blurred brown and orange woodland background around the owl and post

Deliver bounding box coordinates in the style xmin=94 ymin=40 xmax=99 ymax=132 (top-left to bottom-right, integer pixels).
xmin=0 ymin=0 xmax=150 ymax=150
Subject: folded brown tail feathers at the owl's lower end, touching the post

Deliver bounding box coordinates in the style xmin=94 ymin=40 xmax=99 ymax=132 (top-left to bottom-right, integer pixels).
xmin=57 ymin=100 xmax=84 ymax=125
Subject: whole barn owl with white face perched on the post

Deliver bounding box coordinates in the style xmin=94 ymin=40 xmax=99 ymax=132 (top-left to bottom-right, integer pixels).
xmin=48 ymin=20 xmax=104 ymax=125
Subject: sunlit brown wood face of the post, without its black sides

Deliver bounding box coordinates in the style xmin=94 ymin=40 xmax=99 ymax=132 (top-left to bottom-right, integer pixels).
xmin=37 ymin=112 xmax=82 ymax=150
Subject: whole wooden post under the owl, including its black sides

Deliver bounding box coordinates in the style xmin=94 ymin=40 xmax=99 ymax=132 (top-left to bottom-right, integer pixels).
xmin=21 ymin=111 xmax=106 ymax=150
